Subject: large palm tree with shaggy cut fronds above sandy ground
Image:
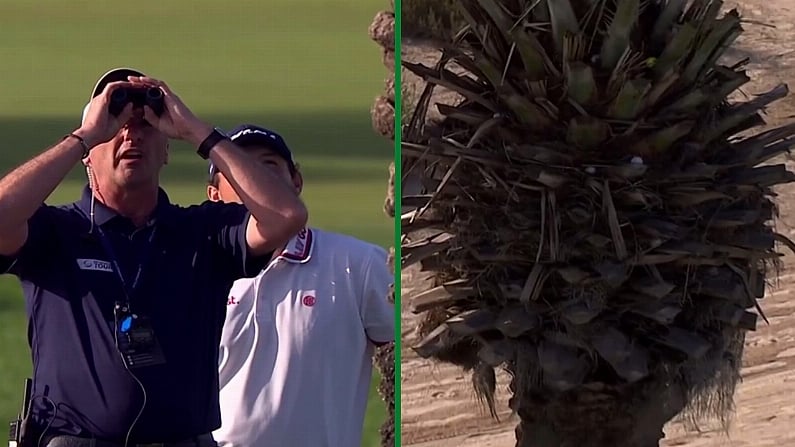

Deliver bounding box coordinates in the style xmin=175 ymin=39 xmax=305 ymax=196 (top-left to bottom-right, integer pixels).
xmin=401 ymin=0 xmax=795 ymax=447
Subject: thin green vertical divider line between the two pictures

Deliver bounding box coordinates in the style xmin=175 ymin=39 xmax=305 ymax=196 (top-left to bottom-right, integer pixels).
xmin=395 ymin=0 xmax=403 ymax=447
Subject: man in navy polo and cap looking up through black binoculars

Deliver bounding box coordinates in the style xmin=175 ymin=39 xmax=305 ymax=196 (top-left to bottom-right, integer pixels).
xmin=0 ymin=69 xmax=307 ymax=447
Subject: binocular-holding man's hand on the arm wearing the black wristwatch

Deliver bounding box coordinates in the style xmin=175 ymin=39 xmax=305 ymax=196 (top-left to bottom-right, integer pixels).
xmin=128 ymin=76 xmax=213 ymax=146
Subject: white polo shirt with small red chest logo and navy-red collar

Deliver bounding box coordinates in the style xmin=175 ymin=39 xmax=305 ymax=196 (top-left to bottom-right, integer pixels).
xmin=213 ymin=229 xmax=395 ymax=447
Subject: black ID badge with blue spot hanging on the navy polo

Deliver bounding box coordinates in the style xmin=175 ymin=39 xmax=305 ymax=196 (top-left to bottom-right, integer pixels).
xmin=116 ymin=313 xmax=166 ymax=369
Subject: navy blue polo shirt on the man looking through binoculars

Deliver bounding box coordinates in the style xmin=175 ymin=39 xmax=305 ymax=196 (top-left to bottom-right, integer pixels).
xmin=0 ymin=187 xmax=268 ymax=442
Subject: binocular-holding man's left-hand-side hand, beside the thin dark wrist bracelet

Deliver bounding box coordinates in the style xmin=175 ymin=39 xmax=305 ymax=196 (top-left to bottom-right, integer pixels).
xmin=74 ymin=81 xmax=133 ymax=148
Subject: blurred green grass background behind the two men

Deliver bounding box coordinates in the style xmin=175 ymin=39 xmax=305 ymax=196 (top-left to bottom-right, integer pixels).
xmin=0 ymin=0 xmax=393 ymax=446
